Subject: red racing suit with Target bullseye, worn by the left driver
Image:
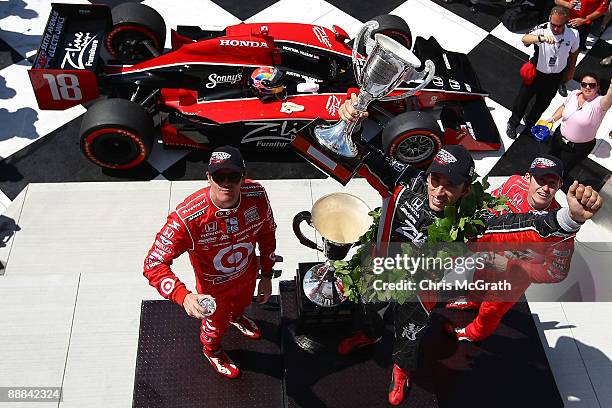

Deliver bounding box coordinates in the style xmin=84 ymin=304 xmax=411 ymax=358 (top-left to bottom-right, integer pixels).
xmin=144 ymin=180 xmax=276 ymax=350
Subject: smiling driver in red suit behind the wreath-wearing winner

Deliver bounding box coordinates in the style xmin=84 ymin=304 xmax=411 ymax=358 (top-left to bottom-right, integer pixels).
xmin=446 ymin=155 xmax=575 ymax=341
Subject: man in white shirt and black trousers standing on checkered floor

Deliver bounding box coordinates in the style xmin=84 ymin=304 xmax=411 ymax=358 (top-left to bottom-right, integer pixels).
xmin=506 ymin=6 xmax=579 ymax=139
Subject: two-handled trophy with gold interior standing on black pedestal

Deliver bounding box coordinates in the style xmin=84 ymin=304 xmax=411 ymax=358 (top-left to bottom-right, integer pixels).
xmin=293 ymin=193 xmax=372 ymax=307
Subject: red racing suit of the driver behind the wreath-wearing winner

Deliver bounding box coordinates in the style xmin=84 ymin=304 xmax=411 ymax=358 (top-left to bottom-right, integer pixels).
xmin=466 ymin=175 xmax=574 ymax=341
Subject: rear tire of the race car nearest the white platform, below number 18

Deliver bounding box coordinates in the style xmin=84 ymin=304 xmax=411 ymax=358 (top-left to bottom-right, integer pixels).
xmin=80 ymin=98 xmax=154 ymax=170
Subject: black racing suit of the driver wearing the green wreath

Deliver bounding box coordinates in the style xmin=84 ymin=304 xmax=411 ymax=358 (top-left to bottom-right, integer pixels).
xmin=358 ymin=167 xmax=570 ymax=371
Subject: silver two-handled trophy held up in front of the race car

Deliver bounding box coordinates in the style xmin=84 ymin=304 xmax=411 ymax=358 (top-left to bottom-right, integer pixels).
xmin=314 ymin=21 xmax=436 ymax=157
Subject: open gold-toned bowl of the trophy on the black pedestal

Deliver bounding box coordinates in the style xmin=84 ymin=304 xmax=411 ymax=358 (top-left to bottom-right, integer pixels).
xmin=311 ymin=193 xmax=372 ymax=244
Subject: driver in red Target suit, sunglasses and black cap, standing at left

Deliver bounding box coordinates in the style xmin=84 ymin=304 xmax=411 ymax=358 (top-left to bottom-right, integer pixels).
xmin=144 ymin=146 xmax=276 ymax=378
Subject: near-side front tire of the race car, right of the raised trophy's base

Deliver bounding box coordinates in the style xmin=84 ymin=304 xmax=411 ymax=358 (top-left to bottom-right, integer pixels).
xmin=382 ymin=112 xmax=443 ymax=167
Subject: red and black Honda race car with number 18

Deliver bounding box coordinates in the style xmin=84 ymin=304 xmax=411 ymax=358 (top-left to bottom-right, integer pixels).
xmin=29 ymin=3 xmax=500 ymax=169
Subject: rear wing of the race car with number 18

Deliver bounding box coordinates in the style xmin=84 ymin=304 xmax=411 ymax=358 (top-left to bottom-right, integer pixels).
xmin=29 ymin=3 xmax=112 ymax=110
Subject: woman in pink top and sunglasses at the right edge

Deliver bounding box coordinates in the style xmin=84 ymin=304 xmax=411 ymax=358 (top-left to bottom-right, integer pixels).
xmin=548 ymin=73 xmax=612 ymax=178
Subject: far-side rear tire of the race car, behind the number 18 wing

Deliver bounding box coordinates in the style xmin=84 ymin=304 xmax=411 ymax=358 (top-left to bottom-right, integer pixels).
xmin=104 ymin=3 xmax=166 ymax=64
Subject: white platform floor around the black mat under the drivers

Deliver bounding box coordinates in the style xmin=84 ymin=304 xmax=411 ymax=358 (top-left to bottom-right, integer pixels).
xmin=0 ymin=178 xmax=612 ymax=408
